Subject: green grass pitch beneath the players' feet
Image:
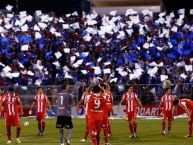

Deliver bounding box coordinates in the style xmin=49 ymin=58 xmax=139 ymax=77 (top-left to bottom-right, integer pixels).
xmin=0 ymin=118 xmax=193 ymax=145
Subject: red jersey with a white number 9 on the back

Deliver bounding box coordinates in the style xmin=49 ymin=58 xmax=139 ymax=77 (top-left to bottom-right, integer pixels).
xmin=88 ymin=93 xmax=106 ymax=119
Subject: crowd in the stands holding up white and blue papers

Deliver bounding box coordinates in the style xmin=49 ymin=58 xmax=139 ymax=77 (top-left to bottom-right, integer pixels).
xmin=0 ymin=6 xmax=193 ymax=95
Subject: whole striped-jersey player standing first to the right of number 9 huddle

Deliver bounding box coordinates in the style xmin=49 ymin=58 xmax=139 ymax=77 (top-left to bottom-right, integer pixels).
xmin=118 ymin=86 xmax=143 ymax=138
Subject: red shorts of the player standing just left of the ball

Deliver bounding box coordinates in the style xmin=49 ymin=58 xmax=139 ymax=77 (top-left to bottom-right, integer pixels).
xmin=5 ymin=114 xmax=20 ymax=127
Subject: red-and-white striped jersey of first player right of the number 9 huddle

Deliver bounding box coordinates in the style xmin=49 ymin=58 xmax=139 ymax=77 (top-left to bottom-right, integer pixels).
xmin=123 ymin=93 xmax=138 ymax=112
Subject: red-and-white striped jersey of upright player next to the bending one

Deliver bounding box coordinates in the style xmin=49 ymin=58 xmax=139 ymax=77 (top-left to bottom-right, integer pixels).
xmin=161 ymin=95 xmax=174 ymax=111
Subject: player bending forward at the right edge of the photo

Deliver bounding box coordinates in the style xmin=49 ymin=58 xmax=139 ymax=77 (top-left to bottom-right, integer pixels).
xmin=173 ymin=99 xmax=193 ymax=137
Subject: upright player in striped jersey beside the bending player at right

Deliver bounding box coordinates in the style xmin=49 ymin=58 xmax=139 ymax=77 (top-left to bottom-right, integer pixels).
xmin=158 ymin=88 xmax=175 ymax=135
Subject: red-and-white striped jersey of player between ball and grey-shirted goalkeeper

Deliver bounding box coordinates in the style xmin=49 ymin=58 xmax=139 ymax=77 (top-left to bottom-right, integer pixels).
xmin=34 ymin=93 xmax=48 ymax=113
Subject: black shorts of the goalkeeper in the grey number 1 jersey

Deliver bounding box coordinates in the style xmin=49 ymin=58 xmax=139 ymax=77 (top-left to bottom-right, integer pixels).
xmin=56 ymin=116 xmax=73 ymax=129
